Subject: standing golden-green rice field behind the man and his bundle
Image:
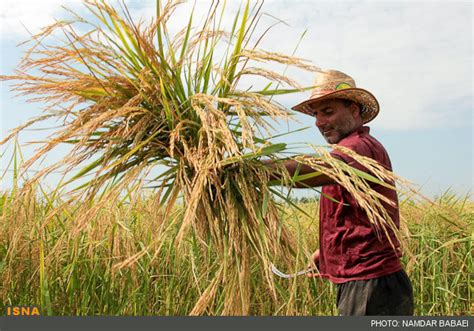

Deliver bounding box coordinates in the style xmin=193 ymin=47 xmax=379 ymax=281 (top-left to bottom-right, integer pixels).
xmin=0 ymin=187 xmax=474 ymax=315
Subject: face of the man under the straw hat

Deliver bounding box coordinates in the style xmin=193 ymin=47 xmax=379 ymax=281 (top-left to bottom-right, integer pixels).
xmin=312 ymin=99 xmax=362 ymax=144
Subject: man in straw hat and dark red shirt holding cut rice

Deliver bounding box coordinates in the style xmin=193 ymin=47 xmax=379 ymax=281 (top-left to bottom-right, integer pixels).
xmin=270 ymin=70 xmax=413 ymax=315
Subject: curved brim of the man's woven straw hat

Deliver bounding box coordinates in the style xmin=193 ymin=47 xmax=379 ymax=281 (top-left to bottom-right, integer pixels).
xmin=291 ymin=87 xmax=380 ymax=124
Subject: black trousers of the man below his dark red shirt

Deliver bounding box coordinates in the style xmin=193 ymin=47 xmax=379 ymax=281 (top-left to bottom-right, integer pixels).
xmin=337 ymin=270 xmax=413 ymax=316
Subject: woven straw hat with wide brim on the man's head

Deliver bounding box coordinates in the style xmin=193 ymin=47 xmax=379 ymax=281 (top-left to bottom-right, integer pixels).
xmin=292 ymin=70 xmax=380 ymax=123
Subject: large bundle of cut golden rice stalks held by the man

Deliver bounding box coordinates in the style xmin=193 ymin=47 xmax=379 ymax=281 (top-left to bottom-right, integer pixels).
xmin=1 ymin=0 xmax=406 ymax=315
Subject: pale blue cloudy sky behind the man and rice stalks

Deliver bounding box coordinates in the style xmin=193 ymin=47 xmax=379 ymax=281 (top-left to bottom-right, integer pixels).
xmin=0 ymin=0 xmax=473 ymax=196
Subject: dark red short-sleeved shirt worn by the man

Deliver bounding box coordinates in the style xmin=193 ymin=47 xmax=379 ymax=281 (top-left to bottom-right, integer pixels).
xmin=319 ymin=127 xmax=402 ymax=283
